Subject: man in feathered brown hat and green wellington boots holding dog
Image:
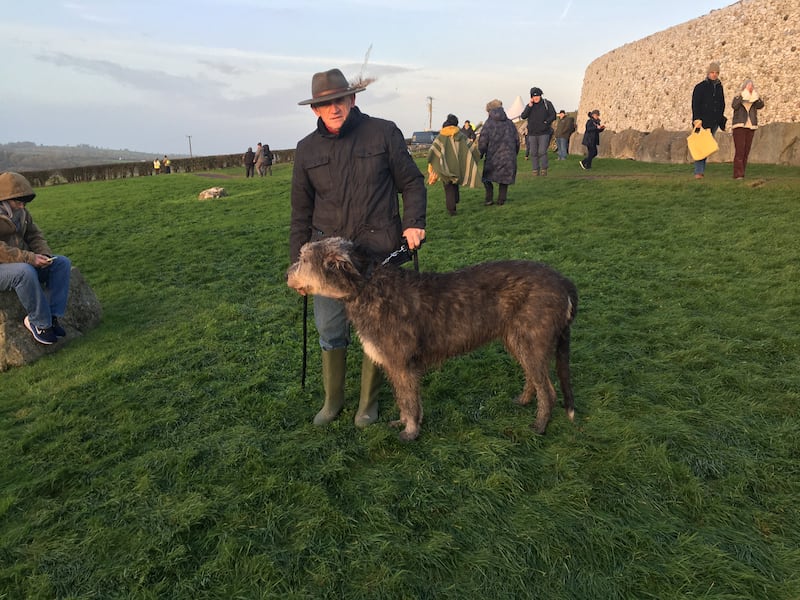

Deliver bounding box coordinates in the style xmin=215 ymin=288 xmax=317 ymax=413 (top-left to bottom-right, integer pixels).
xmin=289 ymin=69 xmax=427 ymax=427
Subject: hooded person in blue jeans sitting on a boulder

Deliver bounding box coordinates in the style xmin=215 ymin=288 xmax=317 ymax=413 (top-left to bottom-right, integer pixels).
xmin=0 ymin=172 xmax=72 ymax=344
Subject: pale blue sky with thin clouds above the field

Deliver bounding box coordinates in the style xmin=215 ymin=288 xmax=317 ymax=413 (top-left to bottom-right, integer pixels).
xmin=0 ymin=0 xmax=732 ymax=156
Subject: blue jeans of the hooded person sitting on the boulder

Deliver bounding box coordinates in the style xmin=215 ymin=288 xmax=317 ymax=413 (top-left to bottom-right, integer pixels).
xmin=0 ymin=256 xmax=72 ymax=329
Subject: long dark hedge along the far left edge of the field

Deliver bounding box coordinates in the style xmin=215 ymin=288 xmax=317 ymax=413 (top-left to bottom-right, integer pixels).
xmin=22 ymin=150 xmax=294 ymax=187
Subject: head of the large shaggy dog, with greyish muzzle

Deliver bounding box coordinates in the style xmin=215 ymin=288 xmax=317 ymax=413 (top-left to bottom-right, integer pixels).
xmin=286 ymin=238 xmax=368 ymax=300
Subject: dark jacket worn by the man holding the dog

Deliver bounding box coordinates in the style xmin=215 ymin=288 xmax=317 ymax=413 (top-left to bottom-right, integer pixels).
xmin=289 ymin=106 xmax=427 ymax=262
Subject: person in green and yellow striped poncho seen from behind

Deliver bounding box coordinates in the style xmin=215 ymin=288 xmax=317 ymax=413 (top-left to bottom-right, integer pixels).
xmin=428 ymin=114 xmax=480 ymax=216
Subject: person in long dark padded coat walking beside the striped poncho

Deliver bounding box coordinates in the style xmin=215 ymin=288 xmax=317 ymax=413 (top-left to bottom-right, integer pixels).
xmin=478 ymin=99 xmax=519 ymax=206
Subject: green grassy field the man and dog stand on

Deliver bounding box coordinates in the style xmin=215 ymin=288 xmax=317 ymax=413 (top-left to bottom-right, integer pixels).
xmin=0 ymin=157 xmax=800 ymax=600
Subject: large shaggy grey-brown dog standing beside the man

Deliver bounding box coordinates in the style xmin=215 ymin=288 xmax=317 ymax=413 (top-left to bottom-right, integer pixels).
xmin=287 ymin=238 xmax=578 ymax=440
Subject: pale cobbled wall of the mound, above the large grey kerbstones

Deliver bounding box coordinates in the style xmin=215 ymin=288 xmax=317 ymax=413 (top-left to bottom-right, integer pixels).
xmin=576 ymin=0 xmax=800 ymax=134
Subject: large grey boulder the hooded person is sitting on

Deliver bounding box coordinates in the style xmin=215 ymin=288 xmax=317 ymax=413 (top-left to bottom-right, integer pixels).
xmin=0 ymin=267 xmax=102 ymax=371
